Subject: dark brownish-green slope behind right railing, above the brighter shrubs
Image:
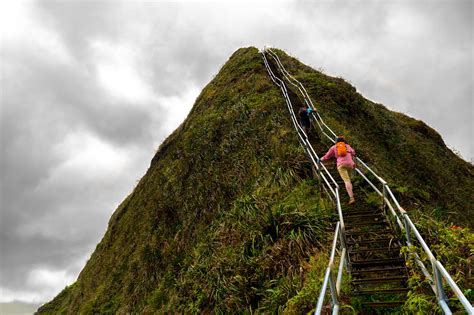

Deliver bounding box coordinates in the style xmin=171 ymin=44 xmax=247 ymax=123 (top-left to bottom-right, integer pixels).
xmin=272 ymin=50 xmax=474 ymax=227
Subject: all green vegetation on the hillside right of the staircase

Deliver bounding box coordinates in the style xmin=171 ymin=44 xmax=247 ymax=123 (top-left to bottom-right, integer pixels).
xmin=268 ymin=50 xmax=474 ymax=314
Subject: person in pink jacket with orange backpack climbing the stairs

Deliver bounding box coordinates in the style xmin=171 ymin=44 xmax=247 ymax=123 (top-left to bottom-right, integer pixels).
xmin=321 ymin=136 xmax=355 ymax=205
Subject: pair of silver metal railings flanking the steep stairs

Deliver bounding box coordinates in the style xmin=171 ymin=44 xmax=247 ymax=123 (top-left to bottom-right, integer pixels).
xmin=262 ymin=48 xmax=474 ymax=314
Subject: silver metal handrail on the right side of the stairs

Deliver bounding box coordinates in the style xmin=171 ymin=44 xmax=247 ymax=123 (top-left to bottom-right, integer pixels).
xmin=262 ymin=47 xmax=474 ymax=314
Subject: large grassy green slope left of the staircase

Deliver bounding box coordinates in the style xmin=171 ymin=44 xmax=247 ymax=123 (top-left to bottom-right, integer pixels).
xmin=39 ymin=48 xmax=332 ymax=314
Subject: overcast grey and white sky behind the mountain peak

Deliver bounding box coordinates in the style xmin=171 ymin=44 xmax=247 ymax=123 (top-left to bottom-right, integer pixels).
xmin=0 ymin=0 xmax=474 ymax=303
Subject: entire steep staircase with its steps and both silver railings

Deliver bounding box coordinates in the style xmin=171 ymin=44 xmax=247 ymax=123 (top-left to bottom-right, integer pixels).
xmin=261 ymin=48 xmax=474 ymax=314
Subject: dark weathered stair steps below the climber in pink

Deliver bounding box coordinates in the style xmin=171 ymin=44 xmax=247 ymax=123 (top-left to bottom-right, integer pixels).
xmin=329 ymin=167 xmax=408 ymax=312
